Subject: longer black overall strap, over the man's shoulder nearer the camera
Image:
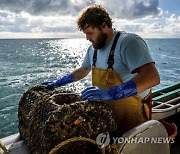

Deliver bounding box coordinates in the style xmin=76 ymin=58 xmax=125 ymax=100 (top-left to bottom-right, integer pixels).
xmin=107 ymin=32 xmax=120 ymax=68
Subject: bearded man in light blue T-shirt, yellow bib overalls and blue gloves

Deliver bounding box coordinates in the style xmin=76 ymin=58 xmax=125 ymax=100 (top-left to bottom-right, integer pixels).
xmin=44 ymin=5 xmax=160 ymax=133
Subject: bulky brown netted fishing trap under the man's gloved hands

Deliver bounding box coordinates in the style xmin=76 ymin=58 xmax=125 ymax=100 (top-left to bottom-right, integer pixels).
xmin=18 ymin=85 xmax=117 ymax=154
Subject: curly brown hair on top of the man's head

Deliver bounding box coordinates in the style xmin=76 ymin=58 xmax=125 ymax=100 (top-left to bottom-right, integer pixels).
xmin=77 ymin=4 xmax=112 ymax=31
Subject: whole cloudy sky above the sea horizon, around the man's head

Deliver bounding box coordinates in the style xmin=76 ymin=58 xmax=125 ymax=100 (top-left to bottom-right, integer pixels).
xmin=0 ymin=0 xmax=180 ymax=39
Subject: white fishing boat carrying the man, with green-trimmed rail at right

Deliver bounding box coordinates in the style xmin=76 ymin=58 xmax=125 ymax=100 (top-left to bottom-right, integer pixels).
xmin=0 ymin=83 xmax=180 ymax=154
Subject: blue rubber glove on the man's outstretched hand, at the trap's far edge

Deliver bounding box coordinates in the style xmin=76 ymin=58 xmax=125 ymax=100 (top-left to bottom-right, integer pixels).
xmin=42 ymin=73 xmax=74 ymax=87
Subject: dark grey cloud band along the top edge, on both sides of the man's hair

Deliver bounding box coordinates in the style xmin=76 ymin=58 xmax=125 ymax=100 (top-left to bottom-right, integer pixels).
xmin=0 ymin=0 xmax=161 ymax=19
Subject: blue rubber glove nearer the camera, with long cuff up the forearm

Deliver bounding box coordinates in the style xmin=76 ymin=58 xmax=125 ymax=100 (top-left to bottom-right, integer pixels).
xmin=81 ymin=80 xmax=137 ymax=101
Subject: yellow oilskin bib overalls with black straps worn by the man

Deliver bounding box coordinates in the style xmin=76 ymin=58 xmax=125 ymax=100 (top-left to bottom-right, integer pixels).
xmin=92 ymin=32 xmax=151 ymax=133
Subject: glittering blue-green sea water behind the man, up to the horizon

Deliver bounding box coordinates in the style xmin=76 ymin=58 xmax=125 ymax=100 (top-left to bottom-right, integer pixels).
xmin=0 ymin=38 xmax=180 ymax=138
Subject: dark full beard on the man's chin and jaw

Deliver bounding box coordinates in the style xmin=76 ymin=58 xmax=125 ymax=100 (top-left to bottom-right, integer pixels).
xmin=92 ymin=31 xmax=108 ymax=49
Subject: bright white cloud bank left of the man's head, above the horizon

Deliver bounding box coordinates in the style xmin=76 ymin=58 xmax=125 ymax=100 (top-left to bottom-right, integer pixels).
xmin=0 ymin=10 xmax=76 ymax=33
